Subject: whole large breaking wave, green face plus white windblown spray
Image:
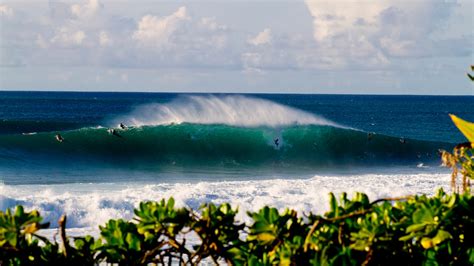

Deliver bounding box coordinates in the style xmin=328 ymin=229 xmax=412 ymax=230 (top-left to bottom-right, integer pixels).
xmin=0 ymin=95 xmax=453 ymax=168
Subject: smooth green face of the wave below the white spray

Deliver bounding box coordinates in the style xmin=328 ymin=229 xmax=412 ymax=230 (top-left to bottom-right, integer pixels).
xmin=0 ymin=123 xmax=451 ymax=167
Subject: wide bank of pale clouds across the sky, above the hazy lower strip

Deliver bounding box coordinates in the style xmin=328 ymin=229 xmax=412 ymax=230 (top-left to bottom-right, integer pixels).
xmin=0 ymin=0 xmax=473 ymax=94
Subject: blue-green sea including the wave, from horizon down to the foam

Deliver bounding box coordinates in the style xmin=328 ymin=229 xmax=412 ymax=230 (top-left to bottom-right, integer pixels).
xmin=0 ymin=92 xmax=474 ymax=183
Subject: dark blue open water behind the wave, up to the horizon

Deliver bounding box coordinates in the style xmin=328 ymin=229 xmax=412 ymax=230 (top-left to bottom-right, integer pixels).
xmin=0 ymin=92 xmax=474 ymax=143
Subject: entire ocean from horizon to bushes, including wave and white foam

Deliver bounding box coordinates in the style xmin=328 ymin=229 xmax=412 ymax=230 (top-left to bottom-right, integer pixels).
xmin=0 ymin=91 xmax=474 ymax=237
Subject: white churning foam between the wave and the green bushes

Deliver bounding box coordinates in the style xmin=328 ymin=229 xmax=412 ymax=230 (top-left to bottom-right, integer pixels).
xmin=0 ymin=172 xmax=450 ymax=237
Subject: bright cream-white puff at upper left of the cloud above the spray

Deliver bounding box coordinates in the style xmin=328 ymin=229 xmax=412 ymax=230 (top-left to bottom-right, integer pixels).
xmin=132 ymin=6 xmax=189 ymax=47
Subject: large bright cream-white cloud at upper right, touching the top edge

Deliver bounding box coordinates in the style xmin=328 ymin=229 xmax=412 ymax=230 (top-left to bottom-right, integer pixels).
xmin=304 ymin=0 xmax=465 ymax=68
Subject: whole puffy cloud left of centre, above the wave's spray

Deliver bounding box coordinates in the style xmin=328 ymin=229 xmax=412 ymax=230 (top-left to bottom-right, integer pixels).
xmin=126 ymin=6 xmax=233 ymax=68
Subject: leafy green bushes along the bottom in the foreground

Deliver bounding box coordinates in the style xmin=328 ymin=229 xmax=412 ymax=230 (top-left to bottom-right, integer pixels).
xmin=0 ymin=190 xmax=474 ymax=265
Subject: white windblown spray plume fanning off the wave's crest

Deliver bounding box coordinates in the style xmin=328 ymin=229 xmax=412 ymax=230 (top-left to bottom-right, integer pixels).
xmin=112 ymin=95 xmax=341 ymax=128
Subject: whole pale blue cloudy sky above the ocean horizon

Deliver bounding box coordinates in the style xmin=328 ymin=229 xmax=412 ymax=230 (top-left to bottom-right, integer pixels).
xmin=0 ymin=0 xmax=474 ymax=95
